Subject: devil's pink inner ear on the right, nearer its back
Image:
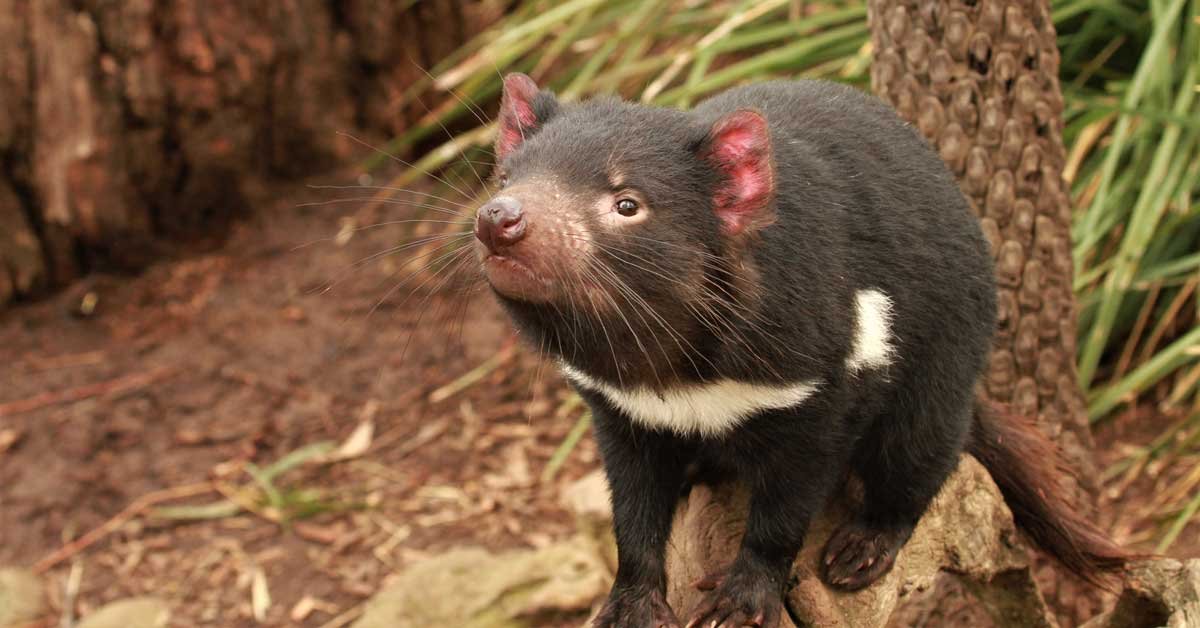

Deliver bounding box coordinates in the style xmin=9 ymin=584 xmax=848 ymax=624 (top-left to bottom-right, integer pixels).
xmin=704 ymin=109 xmax=775 ymax=235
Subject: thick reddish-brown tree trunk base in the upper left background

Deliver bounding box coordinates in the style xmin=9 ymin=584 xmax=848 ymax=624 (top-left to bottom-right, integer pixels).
xmin=0 ymin=0 xmax=498 ymax=306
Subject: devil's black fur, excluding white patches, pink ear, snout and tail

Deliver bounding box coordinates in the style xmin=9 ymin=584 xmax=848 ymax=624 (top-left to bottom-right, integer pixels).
xmin=480 ymin=82 xmax=1123 ymax=627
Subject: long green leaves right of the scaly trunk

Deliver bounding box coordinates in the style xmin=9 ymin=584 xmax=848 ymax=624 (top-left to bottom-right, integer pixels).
xmin=1060 ymin=0 xmax=1200 ymax=427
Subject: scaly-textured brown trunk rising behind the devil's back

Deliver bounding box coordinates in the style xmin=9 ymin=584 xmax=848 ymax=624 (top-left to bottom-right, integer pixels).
xmin=869 ymin=0 xmax=1098 ymax=620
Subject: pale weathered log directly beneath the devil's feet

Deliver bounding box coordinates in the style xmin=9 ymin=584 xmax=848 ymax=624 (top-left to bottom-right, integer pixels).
xmin=667 ymin=456 xmax=1057 ymax=628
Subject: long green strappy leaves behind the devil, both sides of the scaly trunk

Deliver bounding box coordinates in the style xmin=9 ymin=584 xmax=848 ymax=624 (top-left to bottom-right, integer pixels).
xmin=388 ymin=0 xmax=1200 ymax=420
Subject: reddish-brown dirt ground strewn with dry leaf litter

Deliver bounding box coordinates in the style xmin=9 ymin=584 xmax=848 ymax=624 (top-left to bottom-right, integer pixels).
xmin=0 ymin=174 xmax=1196 ymax=626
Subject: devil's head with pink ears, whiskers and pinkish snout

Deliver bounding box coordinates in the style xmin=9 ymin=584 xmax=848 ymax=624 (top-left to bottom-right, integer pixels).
xmin=475 ymin=74 xmax=775 ymax=385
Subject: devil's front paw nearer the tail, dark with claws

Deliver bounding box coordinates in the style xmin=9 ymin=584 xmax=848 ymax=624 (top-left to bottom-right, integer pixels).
xmin=686 ymin=570 xmax=784 ymax=628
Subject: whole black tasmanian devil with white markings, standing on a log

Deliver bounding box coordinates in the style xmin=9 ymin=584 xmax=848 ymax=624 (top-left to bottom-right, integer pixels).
xmin=475 ymin=74 xmax=1123 ymax=628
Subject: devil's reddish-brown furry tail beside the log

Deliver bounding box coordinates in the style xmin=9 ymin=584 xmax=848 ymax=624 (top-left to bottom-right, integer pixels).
xmin=967 ymin=401 xmax=1136 ymax=587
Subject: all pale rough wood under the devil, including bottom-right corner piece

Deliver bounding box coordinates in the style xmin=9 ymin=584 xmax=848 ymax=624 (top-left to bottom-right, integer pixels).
xmin=667 ymin=456 xmax=1200 ymax=628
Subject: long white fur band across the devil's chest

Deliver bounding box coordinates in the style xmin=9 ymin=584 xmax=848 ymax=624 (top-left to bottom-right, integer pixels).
xmin=562 ymin=364 xmax=820 ymax=436
